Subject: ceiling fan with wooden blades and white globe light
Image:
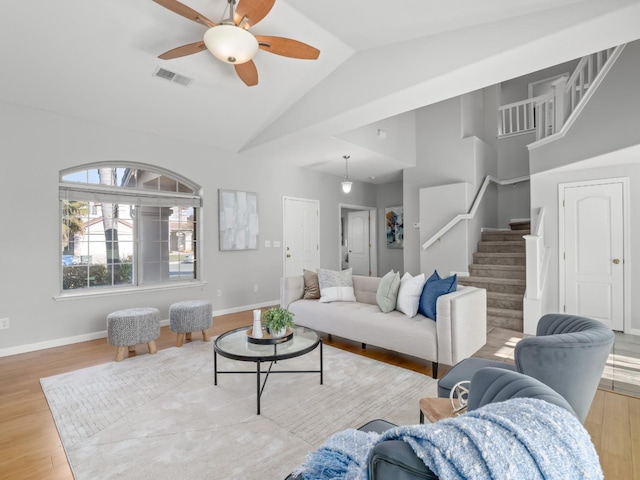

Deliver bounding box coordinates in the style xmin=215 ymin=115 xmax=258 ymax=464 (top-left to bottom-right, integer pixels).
xmin=153 ymin=0 xmax=320 ymax=87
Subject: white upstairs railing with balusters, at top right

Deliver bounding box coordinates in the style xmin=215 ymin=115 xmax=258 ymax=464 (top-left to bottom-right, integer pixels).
xmin=498 ymin=45 xmax=625 ymax=141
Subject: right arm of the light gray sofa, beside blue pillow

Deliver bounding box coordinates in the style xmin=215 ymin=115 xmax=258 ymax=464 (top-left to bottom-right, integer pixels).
xmin=436 ymin=287 xmax=487 ymax=365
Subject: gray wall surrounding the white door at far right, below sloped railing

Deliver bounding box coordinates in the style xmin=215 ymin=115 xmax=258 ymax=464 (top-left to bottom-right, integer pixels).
xmin=530 ymin=41 xmax=640 ymax=334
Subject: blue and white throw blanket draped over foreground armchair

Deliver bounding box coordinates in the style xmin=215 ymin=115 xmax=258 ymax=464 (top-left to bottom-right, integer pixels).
xmin=296 ymin=398 xmax=604 ymax=480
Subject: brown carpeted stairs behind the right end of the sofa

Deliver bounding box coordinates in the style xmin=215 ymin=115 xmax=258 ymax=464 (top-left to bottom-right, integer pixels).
xmin=458 ymin=221 xmax=531 ymax=332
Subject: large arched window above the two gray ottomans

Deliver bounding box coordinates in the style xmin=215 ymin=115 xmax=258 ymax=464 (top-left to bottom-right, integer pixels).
xmin=59 ymin=162 xmax=202 ymax=292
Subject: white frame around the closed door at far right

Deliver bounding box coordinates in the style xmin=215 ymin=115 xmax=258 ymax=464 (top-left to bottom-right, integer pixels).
xmin=558 ymin=177 xmax=631 ymax=333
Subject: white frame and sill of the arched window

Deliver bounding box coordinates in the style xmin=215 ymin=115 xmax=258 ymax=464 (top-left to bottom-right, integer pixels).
xmin=54 ymin=161 xmax=204 ymax=299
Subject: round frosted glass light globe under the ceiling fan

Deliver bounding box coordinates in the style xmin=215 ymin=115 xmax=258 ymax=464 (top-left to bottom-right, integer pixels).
xmin=204 ymin=25 xmax=259 ymax=65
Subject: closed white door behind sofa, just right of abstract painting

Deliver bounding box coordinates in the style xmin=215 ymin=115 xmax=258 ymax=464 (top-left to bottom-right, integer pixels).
xmin=283 ymin=197 xmax=320 ymax=277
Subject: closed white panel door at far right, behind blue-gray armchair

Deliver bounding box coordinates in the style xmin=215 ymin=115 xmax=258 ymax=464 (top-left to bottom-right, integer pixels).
xmin=564 ymin=183 xmax=624 ymax=330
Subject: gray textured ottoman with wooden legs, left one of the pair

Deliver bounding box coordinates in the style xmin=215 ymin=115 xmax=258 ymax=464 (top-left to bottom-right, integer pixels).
xmin=107 ymin=307 xmax=160 ymax=362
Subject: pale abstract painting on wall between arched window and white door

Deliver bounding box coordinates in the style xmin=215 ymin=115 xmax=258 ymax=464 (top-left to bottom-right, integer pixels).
xmin=218 ymin=189 xmax=258 ymax=251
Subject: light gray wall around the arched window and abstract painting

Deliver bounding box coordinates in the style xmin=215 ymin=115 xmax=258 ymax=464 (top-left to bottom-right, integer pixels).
xmin=0 ymin=104 xmax=376 ymax=355
